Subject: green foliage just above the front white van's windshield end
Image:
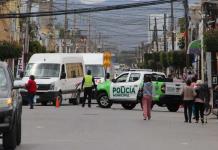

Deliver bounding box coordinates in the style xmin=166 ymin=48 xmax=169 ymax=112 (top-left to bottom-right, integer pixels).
xmin=28 ymin=41 xmax=46 ymax=58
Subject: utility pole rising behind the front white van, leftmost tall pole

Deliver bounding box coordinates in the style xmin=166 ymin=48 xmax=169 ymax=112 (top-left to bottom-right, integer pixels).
xmin=24 ymin=0 xmax=32 ymax=66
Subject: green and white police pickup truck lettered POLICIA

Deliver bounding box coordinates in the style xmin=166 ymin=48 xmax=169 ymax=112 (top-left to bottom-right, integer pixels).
xmin=97 ymin=71 xmax=184 ymax=112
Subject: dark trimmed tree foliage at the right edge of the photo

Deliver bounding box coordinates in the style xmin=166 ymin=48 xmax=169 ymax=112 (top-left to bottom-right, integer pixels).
xmin=204 ymin=29 xmax=218 ymax=52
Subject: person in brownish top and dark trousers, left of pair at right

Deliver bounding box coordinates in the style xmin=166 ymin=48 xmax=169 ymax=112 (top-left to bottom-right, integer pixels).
xmin=182 ymin=80 xmax=196 ymax=123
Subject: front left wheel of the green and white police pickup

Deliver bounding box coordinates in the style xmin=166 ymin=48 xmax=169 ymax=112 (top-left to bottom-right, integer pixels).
xmin=97 ymin=93 xmax=112 ymax=108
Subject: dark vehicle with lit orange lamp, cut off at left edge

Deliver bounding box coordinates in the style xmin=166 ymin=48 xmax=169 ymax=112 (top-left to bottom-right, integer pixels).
xmin=0 ymin=62 xmax=22 ymax=150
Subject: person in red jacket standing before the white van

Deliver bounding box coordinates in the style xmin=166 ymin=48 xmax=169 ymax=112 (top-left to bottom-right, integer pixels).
xmin=25 ymin=75 xmax=37 ymax=109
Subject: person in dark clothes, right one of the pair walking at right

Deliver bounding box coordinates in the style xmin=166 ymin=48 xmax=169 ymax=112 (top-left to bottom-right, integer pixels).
xmin=195 ymin=80 xmax=209 ymax=123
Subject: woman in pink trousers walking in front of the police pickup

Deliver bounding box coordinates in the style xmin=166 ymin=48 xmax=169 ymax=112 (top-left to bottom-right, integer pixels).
xmin=142 ymin=75 xmax=152 ymax=120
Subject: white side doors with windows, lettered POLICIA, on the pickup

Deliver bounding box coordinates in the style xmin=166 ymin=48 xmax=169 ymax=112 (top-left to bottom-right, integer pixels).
xmin=110 ymin=73 xmax=140 ymax=101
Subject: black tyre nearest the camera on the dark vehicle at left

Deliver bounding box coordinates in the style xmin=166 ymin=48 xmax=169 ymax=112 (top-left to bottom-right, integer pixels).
xmin=2 ymin=119 xmax=17 ymax=150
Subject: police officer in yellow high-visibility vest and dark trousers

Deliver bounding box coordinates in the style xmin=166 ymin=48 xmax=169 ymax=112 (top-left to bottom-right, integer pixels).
xmin=82 ymin=70 xmax=96 ymax=107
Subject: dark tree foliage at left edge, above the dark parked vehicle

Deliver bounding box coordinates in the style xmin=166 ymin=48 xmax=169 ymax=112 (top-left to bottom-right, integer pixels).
xmin=0 ymin=41 xmax=22 ymax=61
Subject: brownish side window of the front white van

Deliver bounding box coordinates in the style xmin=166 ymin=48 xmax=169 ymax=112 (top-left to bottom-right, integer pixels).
xmin=66 ymin=63 xmax=83 ymax=78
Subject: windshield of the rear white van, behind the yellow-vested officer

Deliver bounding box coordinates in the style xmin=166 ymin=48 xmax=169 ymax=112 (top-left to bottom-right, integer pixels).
xmin=85 ymin=65 xmax=104 ymax=77
